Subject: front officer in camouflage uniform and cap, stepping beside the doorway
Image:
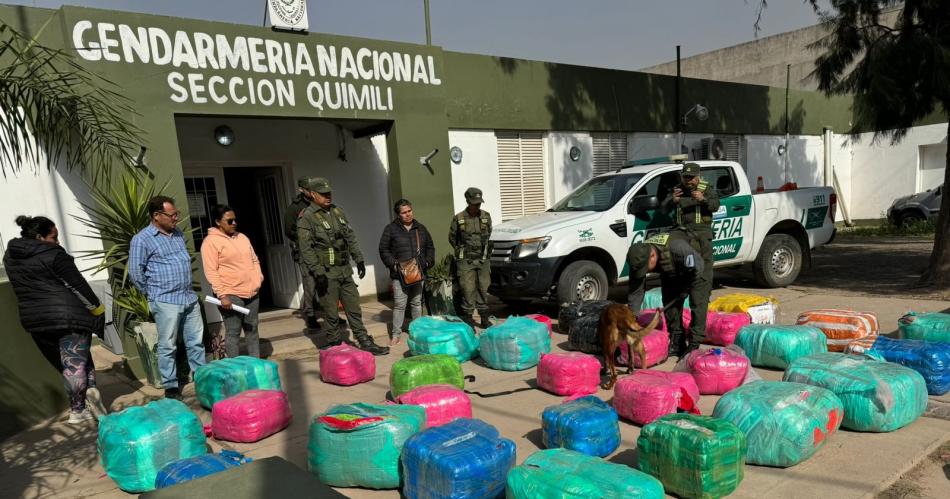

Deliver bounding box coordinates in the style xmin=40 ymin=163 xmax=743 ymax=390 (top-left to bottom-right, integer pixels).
xmin=297 ymin=177 xmax=389 ymax=355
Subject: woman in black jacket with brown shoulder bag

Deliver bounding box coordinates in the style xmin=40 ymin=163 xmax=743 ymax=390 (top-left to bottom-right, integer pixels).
xmin=379 ymin=199 xmax=435 ymax=345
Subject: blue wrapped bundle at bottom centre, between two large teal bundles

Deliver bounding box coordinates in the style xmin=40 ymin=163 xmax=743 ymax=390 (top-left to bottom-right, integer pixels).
xmin=402 ymin=418 xmax=520 ymax=499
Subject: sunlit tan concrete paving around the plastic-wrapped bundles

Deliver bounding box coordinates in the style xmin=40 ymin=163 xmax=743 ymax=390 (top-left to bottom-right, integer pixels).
xmin=0 ymin=234 xmax=950 ymax=498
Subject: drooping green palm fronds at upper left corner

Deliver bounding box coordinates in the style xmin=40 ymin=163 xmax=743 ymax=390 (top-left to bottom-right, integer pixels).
xmin=0 ymin=21 xmax=140 ymax=182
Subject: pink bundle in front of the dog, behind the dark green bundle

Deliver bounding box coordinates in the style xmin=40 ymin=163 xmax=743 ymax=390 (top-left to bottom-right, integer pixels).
xmin=613 ymin=370 xmax=699 ymax=425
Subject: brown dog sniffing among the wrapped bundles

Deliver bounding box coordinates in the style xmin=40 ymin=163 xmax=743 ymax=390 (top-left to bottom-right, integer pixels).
xmin=597 ymin=303 xmax=660 ymax=390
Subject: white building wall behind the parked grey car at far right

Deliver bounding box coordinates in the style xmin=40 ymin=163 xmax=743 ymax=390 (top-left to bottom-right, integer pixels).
xmin=849 ymin=123 xmax=947 ymax=219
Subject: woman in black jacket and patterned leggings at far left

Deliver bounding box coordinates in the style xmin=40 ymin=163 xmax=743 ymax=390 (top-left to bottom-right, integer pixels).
xmin=3 ymin=215 xmax=105 ymax=424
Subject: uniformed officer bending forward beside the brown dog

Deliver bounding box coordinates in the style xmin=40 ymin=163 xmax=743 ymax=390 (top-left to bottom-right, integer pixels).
xmin=627 ymin=230 xmax=709 ymax=357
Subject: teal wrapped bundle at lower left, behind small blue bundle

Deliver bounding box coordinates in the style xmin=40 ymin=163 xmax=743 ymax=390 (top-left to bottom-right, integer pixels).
xmin=97 ymin=399 xmax=208 ymax=492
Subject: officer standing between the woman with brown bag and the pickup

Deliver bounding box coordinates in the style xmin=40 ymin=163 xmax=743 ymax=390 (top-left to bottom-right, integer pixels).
xmin=449 ymin=187 xmax=491 ymax=328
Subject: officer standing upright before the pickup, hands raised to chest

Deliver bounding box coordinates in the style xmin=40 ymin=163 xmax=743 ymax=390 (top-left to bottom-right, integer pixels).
xmin=663 ymin=163 xmax=719 ymax=352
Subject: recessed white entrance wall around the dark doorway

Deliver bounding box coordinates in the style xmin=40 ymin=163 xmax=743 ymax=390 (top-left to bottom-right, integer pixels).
xmin=176 ymin=117 xmax=393 ymax=296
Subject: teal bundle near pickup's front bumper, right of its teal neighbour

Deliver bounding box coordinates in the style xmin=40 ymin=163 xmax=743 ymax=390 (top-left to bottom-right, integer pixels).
xmin=478 ymin=317 xmax=551 ymax=371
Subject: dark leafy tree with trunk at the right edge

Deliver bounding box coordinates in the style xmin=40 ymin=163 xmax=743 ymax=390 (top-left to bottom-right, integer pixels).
xmin=756 ymin=0 xmax=950 ymax=288
